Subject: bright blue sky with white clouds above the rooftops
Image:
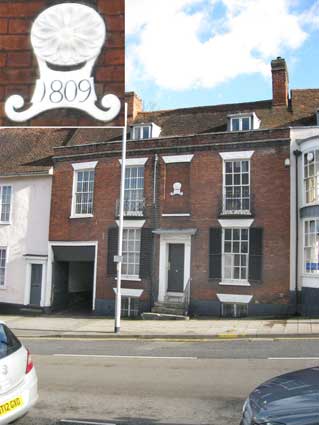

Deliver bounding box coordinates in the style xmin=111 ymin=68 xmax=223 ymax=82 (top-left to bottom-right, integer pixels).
xmin=125 ymin=0 xmax=319 ymax=111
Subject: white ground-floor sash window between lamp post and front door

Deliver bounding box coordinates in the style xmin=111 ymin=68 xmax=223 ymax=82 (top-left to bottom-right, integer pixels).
xmin=122 ymin=229 xmax=141 ymax=277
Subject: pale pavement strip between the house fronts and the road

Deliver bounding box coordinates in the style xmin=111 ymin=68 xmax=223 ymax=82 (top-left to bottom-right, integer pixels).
xmin=0 ymin=314 xmax=319 ymax=339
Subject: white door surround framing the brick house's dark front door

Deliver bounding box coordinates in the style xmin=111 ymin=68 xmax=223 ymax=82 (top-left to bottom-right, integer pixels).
xmin=158 ymin=232 xmax=192 ymax=302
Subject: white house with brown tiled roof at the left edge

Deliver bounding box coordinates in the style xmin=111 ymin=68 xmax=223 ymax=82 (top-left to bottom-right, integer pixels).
xmin=0 ymin=129 xmax=68 ymax=310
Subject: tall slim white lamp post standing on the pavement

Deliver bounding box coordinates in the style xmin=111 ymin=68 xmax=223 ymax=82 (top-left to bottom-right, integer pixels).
xmin=114 ymin=103 xmax=127 ymax=333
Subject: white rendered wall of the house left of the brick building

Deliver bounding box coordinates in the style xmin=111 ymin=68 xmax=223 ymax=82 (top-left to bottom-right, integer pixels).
xmin=0 ymin=176 xmax=52 ymax=304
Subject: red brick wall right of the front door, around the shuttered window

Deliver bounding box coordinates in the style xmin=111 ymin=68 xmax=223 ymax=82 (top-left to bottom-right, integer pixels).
xmin=185 ymin=146 xmax=290 ymax=304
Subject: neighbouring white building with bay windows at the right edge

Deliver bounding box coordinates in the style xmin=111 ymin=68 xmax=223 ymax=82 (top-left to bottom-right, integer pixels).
xmin=290 ymin=124 xmax=319 ymax=316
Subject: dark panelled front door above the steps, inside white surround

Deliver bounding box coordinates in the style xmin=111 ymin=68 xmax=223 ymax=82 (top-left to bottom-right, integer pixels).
xmin=167 ymin=243 xmax=185 ymax=292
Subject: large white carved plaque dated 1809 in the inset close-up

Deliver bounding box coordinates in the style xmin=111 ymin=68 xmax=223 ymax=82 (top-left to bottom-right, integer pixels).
xmin=5 ymin=3 xmax=121 ymax=122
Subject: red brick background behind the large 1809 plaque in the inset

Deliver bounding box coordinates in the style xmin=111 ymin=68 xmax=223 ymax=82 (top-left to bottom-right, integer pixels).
xmin=0 ymin=0 xmax=124 ymax=126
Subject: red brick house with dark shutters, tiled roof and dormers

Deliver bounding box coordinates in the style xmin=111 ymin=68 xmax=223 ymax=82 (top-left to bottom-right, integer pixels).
xmin=43 ymin=58 xmax=319 ymax=316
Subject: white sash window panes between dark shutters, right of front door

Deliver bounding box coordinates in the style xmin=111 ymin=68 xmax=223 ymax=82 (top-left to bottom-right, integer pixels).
xmin=223 ymin=228 xmax=249 ymax=281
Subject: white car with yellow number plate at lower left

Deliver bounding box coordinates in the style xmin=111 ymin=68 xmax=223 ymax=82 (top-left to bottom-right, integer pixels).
xmin=0 ymin=322 xmax=38 ymax=425
